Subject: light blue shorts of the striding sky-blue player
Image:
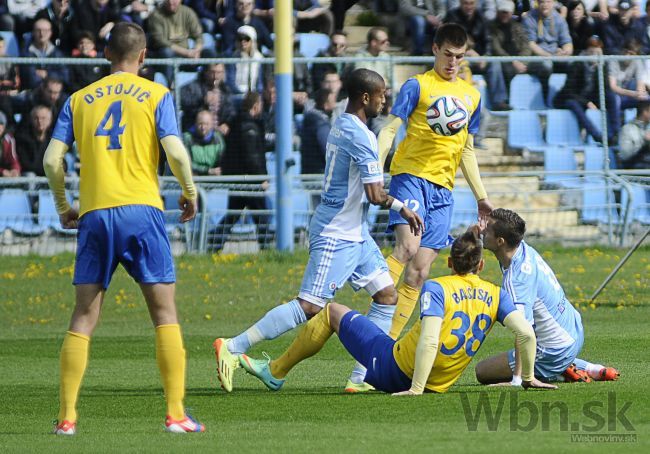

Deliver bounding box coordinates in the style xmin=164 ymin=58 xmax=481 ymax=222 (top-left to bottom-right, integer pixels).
xmin=298 ymin=235 xmax=393 ymax=307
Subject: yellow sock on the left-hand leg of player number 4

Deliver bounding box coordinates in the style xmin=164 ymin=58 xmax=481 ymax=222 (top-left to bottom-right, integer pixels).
xmin=59 ymin=331 xmax=90 ymax=423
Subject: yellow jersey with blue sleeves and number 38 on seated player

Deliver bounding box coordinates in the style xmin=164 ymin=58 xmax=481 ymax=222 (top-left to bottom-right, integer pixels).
xmin=393 ymin=274 xmax=516 ymax=393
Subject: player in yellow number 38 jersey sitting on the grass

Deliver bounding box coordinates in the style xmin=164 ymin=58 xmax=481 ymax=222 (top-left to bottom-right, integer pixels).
xmin=235 ymin=226 xmax=556 ymax=395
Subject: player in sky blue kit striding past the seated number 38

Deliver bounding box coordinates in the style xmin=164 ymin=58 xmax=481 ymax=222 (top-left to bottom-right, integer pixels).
xmin=214 ymin=69 xmax=423 ymax=392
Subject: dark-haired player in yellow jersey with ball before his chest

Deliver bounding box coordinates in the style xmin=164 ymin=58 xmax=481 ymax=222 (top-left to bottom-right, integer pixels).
xmin=364 ymin=24 xmax=492 ymax=380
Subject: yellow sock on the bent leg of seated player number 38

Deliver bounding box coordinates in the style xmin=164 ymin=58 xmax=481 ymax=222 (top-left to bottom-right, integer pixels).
xmin=271 ymin=305 xmax=334 ymax=378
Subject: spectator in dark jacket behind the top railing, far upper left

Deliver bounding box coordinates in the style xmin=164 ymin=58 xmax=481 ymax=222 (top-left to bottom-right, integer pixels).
xmin=21 ymin=19 xmax=68 ymax=88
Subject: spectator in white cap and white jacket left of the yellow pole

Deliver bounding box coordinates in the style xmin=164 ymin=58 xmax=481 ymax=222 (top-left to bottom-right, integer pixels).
xmin=226 ymin=25 xmax=264 ymax=94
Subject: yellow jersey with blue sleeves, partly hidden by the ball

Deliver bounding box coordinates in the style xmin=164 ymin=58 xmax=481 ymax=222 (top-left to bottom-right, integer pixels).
xmin=390 ymin=69 xmax=481 ymax=190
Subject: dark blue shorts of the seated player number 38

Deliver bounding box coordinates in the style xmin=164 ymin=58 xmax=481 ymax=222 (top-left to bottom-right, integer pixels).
xmin=339 ymin=311 xmax=411 ymax=393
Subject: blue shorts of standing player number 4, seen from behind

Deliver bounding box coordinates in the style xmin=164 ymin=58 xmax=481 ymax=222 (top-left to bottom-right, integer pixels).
xmin=72 ymin=205 xmax=176 ymax=288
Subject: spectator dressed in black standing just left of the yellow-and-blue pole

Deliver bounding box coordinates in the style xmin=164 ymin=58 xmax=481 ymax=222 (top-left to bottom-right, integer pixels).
xmin=216 ymin=92 xmax=269 ymax=248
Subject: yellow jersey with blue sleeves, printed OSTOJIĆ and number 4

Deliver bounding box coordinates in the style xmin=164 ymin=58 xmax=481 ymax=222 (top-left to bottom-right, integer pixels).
xmin=52 ymin=72 xmax=179 ymax=216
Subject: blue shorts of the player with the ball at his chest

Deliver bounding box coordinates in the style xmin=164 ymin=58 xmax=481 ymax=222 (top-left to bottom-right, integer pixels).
xmin=388 ymin=173 xmax=454 ymax=249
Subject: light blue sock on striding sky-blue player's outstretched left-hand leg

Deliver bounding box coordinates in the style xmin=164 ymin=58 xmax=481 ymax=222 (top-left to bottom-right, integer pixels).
xmin=228 ymin=299 xmax=306 ymax=355
